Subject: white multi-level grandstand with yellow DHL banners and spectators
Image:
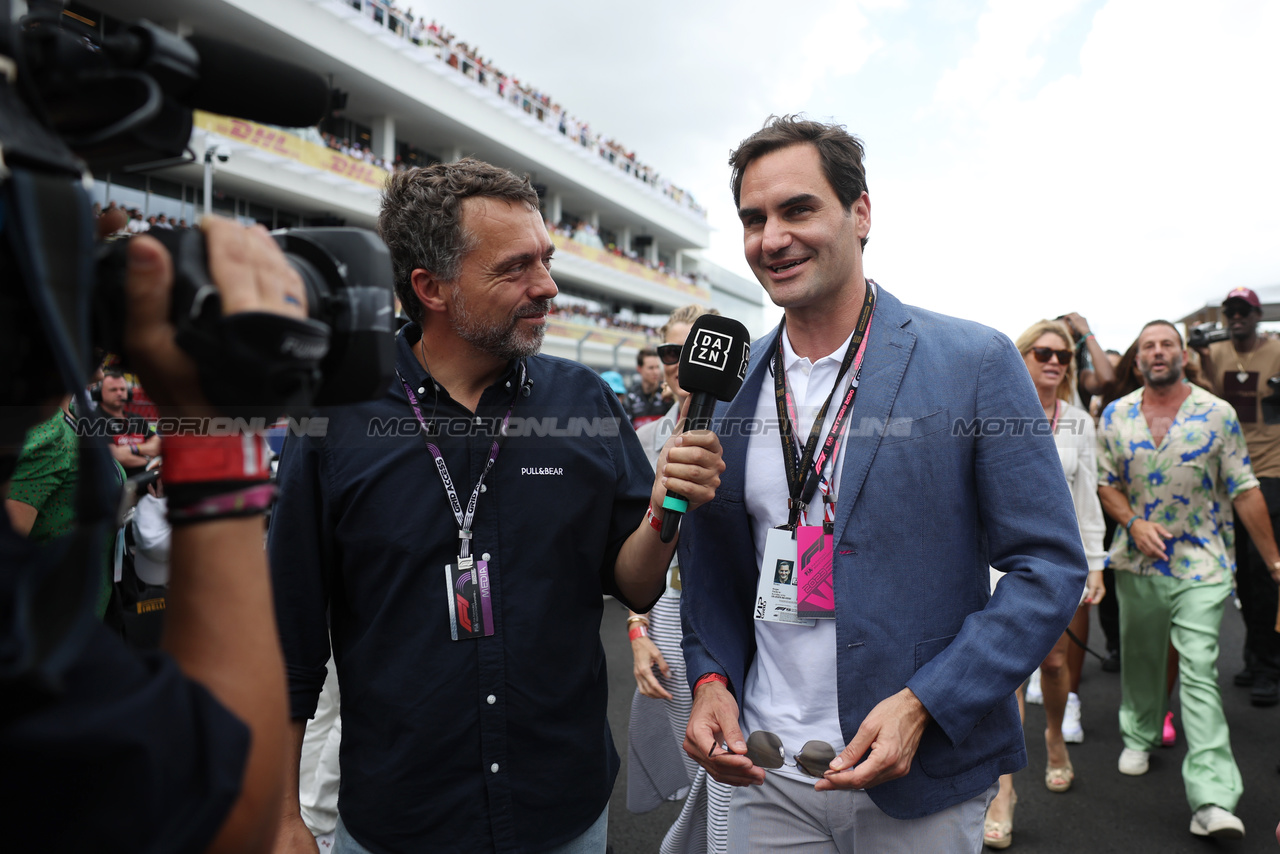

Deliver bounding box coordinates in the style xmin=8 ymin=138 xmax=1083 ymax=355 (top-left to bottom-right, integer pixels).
xmin=68 ymin=0 xmax=764 ymax=371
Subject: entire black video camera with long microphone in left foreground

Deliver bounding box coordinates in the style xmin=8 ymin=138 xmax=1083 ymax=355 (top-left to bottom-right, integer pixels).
xmin=0 ymin=3 xmax=396 ymax=419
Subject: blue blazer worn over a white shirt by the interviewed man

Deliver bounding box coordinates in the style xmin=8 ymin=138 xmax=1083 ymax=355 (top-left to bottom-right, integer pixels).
xmin=680 ymin=288 xmax=1087 ymax=819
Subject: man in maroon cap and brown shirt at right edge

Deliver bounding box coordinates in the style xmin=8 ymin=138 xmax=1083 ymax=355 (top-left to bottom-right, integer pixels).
xmin=1189 ymin=288 xmax=1280 ymax=707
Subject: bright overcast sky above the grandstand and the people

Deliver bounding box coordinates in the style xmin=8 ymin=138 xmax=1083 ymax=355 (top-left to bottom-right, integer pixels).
xmin=422 ymin=0 xmax=1280 ymax=351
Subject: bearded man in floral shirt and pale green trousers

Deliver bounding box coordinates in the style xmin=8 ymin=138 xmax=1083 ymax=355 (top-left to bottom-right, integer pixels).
xmin=1098 ymin=320 xmax=1280 ymax=839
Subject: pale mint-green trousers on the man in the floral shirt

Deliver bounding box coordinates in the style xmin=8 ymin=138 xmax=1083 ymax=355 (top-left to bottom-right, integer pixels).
xmin=1115 ymin=572 xmax=1244 ymax=812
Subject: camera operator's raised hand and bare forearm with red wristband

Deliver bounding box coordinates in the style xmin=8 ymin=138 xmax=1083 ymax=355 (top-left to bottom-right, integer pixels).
xmin=110 ymin=218 xmax=302 ymax=854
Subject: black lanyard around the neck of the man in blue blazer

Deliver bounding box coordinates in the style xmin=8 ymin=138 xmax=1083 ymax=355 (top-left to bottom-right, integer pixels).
xmin=773 ymin=282 xmax=876 ymax=530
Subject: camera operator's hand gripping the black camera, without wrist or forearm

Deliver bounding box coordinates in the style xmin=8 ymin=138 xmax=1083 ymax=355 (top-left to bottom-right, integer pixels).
xmin=124 ymin=216 xmax=307 ymax=416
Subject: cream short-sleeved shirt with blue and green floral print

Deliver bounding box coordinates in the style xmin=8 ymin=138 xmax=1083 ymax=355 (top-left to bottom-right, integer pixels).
xmin=1098 ymin=385 xmax=1258 ymax=581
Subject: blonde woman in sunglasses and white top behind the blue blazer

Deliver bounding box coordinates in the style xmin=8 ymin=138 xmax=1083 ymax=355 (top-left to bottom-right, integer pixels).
xmin=983 ymin=320 xmax=1106 ymax=848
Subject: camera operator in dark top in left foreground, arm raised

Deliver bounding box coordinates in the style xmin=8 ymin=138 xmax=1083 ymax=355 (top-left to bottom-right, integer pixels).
xmin=0 ymin=218 xmax=296 ymax=853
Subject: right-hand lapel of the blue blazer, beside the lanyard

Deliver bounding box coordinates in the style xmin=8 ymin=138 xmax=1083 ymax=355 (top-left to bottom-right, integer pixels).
xmin=835 ymin=286 xmax=915 ymax=542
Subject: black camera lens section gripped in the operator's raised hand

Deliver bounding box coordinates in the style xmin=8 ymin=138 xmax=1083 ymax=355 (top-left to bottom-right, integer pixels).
xmin=91 ymin=228 xmax=396 ymax=419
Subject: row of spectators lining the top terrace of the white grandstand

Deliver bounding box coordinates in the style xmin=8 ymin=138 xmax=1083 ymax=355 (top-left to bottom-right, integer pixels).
xmin=330 ymin=0 xmax=707 ymax=218
